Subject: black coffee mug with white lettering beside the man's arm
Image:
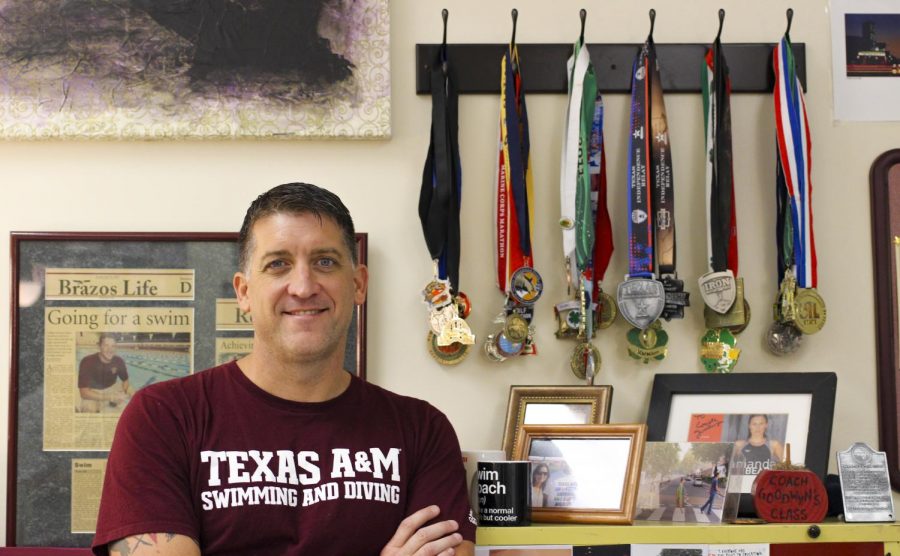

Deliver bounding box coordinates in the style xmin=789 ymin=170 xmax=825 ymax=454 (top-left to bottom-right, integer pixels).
xmin=475 ymin=461 xmax=531 ymax=527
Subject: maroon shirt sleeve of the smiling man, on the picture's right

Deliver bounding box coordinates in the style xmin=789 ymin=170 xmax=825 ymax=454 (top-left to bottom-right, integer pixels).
xmin=407 ymin=406 xmax=476 ymax=543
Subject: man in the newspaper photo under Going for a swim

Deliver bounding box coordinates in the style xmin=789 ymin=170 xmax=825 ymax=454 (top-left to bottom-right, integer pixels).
xmin=78 ymin=333 xmax=131 ymax=413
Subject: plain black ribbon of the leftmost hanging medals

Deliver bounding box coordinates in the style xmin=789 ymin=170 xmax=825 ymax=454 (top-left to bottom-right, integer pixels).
xmin=419 ymin=49 xmax=462 ymax=292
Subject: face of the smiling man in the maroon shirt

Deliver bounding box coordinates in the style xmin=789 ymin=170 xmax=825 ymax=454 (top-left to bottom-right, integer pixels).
xmin=234 ymin=213 xmax=368 ymax=363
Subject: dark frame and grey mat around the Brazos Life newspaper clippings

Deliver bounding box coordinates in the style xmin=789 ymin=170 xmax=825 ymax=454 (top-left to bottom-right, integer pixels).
xmin=6 ymin=232 xmax=368 ymax=547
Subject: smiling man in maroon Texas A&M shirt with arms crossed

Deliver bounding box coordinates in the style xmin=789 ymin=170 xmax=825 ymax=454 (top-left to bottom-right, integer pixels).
xmin=94 ymin=184 xmax=475 ymax=556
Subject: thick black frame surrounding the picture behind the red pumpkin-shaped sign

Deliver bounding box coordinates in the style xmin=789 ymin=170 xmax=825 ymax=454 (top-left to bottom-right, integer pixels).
xmin=647 ymin=372 xmax=837 ymax=515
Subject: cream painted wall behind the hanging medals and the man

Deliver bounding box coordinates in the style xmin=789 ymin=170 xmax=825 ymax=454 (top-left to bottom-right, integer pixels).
xmin=0 ymin=0 xmax=900 ymax=540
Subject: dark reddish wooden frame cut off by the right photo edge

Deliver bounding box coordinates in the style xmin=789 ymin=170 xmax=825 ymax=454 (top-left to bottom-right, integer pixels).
xmin=869 ymin=149 xmax=900 ymax=490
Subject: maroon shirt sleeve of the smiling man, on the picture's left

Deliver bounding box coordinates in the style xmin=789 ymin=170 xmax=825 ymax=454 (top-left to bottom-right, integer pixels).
xmin=92 ymin=387 xmax=199 ymax=555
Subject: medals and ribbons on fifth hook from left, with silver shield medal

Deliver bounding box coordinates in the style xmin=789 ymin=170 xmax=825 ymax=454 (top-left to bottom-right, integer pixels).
xmin=698 ymin=10 xmax=750 ymax=373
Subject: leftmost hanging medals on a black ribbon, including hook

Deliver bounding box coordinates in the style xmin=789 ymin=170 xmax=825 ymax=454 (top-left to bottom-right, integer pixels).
xmin=419 ymin=10 xmax=475 ymax=365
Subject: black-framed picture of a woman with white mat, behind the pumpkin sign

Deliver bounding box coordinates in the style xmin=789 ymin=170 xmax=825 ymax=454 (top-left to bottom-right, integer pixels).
xmin=647 ymin=372 xmax=837 ymax=515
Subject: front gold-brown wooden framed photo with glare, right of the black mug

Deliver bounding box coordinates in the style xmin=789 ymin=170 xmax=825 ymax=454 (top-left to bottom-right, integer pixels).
xmin=514 ymin=424 xmax=647 ymax=524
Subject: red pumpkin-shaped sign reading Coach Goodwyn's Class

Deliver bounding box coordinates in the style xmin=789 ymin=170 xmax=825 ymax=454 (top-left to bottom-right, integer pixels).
xmin=753 ymin=469 xmax=828 ymax=523
